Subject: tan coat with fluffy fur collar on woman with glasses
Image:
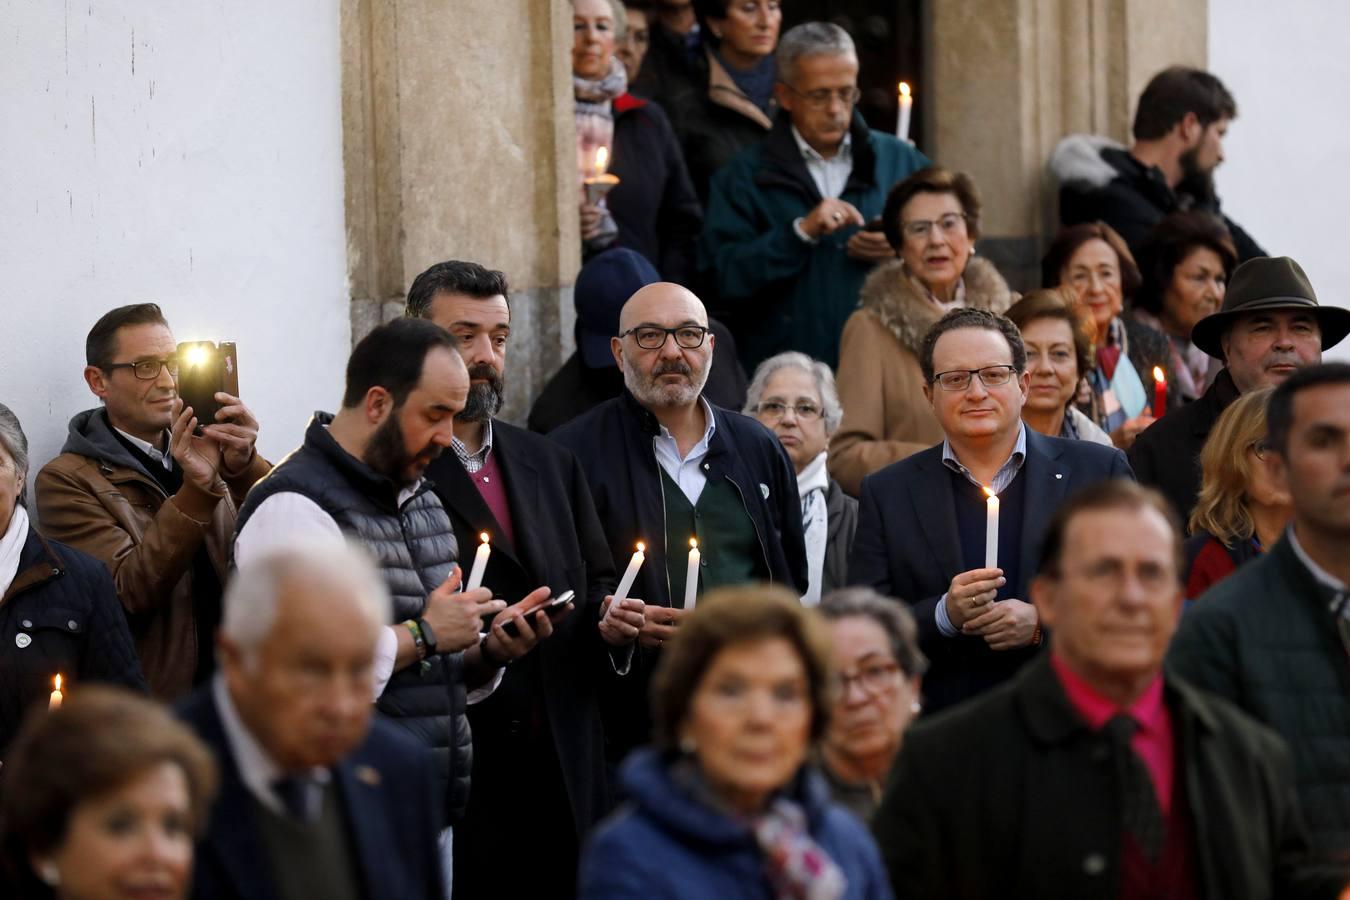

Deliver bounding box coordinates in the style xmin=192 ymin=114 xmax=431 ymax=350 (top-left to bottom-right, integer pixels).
xmin=829 ymin=256 xmax=1013 ymax=497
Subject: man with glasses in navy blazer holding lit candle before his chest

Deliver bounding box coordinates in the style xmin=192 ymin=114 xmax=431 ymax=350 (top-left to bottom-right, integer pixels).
xmin=849 ymin=309 xmax=1133 ymax=710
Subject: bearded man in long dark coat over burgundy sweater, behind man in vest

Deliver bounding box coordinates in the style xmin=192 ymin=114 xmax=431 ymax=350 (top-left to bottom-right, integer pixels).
xmin=406 ymin=260 xmax=631 ymax=899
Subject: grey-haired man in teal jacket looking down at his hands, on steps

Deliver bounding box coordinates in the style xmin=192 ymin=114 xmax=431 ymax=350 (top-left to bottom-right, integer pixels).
xmin=699 ymin=22 xmax=929 ymax=370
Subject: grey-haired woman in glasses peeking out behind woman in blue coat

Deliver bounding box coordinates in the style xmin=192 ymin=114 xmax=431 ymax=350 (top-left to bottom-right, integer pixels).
xmin=819 ymin=587 xmax=927 ymax=822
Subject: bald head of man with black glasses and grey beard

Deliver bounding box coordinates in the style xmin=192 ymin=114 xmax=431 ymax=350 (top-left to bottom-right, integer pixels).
xmin=610 ymin=282 xmax=713 ymax=410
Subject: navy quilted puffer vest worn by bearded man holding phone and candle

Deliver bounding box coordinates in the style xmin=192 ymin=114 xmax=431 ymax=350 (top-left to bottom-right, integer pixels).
xmin=235 ymin=413 xmax=474 ymax=824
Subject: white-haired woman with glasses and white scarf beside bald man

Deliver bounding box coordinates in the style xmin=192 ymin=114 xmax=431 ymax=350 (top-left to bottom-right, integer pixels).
xmin=744 ymin=351 xmax=857 ymax=606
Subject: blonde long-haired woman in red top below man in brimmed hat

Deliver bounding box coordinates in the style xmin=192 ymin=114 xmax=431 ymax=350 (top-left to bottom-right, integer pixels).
xmin=1185 ymin=387 xmax=1293 ymax=599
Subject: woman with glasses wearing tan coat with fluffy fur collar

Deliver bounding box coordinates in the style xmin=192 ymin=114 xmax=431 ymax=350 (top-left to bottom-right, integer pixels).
xmin=830 ymin=166 xmax=1013 ymax=497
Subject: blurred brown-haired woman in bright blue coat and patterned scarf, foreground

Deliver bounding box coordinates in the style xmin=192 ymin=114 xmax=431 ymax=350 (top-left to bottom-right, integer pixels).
xmin=578 ymin=586 xmax=891 ymax=900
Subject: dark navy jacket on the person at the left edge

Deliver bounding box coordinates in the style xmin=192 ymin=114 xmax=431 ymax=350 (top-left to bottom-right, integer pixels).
xmin=0 ymin=526 xmax=146 ymax=758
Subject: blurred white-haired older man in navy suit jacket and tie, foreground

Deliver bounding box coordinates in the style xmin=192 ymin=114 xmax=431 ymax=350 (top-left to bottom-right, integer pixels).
xmin=180 ymin=538 xmax=443 ymax=900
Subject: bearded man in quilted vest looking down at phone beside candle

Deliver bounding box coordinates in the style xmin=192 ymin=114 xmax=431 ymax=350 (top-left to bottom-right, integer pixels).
xmin=235 ymin=318 xmax=551 ymax=895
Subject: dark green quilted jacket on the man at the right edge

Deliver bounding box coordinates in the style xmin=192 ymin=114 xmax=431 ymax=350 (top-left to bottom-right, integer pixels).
xmin=1168 ymin=537 xmax=1350 ymax=854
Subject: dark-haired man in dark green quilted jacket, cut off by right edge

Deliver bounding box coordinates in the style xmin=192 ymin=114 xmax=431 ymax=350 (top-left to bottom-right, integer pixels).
xmin=1168 ymin=363 xmax=1350 ymax=874
